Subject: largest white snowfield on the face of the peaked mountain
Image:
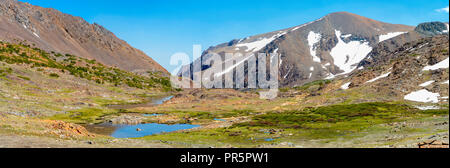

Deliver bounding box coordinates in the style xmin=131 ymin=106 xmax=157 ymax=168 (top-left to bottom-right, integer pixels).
xmin=330 ymin=30 xmax=372 ymax=74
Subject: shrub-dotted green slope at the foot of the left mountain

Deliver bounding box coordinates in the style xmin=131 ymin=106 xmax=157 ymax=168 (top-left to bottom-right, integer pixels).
xmin=0 ymin=41 xmax=171 ymax=91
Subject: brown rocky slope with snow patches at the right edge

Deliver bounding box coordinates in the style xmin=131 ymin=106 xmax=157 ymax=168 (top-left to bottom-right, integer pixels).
xmin=341 ymin=35 xmax=449 ymax=105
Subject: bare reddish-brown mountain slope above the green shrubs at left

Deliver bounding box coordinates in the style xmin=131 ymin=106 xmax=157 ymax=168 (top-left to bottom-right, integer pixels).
xmin=0 ymin=0 xmax=168 ymax=74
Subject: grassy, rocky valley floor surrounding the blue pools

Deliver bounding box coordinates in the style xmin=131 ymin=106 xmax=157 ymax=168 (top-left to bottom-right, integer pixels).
xmin=0 ymin=84 xmax=449 ymax=148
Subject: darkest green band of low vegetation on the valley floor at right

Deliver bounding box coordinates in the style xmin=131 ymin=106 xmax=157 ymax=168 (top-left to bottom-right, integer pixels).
xmin=236 ymin=103 xmax=436 ymax=128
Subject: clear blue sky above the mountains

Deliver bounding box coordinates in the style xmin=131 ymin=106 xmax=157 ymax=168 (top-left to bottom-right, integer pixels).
xmin=21 ymin=0 xmax=449 ymax=72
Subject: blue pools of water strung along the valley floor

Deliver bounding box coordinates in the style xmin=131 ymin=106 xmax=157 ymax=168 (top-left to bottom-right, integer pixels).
xmin=84 ymin=96 xmax=199 ymax=138
